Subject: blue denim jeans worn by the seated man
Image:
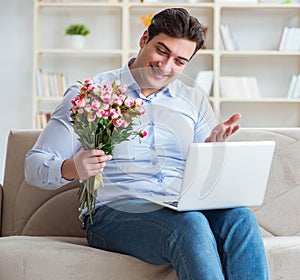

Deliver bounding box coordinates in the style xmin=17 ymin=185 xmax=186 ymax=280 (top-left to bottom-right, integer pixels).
xmin=87 ymin=199 xmax=269 ymax=280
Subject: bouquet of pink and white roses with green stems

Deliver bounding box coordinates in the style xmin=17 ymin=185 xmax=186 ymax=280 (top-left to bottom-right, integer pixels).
xmin=71 ymin=78 xmax=147 ymax=223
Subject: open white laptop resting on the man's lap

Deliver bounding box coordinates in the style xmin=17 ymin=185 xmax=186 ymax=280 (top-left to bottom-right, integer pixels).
xmin=143 ymin=141 xmax=275 ymax=211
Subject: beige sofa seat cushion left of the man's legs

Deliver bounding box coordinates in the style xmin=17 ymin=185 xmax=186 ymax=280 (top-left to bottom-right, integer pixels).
xmin=0 ymin=236 xmax=177 ymax=280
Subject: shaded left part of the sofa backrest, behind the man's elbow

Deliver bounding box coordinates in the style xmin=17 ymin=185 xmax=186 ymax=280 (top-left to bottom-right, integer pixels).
xmin=1 ymin=130 xmax=85 ymax=237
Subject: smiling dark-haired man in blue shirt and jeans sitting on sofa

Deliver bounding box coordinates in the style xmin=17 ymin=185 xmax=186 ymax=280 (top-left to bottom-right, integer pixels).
xmin=25 ymin=8 xmax=268 ymax=280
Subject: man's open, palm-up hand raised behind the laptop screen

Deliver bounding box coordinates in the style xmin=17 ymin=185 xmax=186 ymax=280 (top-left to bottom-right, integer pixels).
xmin=205 ymin=114 xmax=241 ymax=142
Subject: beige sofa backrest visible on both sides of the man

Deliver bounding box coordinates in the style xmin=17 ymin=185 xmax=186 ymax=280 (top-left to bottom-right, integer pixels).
xmin=2 ymin=128 xmax=300 ymax=237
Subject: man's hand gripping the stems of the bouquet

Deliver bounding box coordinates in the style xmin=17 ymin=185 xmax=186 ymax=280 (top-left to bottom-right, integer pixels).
xmin=61 ymin=150 xmax=112 ymax=180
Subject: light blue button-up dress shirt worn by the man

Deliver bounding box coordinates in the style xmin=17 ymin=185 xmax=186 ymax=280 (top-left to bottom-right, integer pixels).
xmin=25 ymin=62 xmax=216 ymax=214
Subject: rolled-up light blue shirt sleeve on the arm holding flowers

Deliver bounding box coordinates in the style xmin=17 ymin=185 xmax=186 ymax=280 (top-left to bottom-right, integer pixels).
xmin=25 ymin=85 xmax=81 ymax=189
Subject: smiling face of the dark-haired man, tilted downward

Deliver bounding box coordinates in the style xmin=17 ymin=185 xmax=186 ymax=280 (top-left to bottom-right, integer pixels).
xmin=130 ymin=30 xmax=196 ymax=96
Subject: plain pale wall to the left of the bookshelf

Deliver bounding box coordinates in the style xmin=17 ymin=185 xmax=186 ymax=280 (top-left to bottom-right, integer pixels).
xmin=0 ymin=0 xmax=33 ymax=184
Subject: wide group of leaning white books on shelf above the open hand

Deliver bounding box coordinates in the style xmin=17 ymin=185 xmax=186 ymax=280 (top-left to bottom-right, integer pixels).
xmin=220 ymin=76 xmax=260 ymax=99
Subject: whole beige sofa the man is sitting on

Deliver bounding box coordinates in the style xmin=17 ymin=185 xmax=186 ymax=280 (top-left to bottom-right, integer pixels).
xmin=0 ymin=129 xmax=300 ymax=280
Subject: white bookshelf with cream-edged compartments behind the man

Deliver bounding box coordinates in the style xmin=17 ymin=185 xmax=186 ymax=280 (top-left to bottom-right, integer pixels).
xmin=33 ymin=0 xmax=300 ymax=127
